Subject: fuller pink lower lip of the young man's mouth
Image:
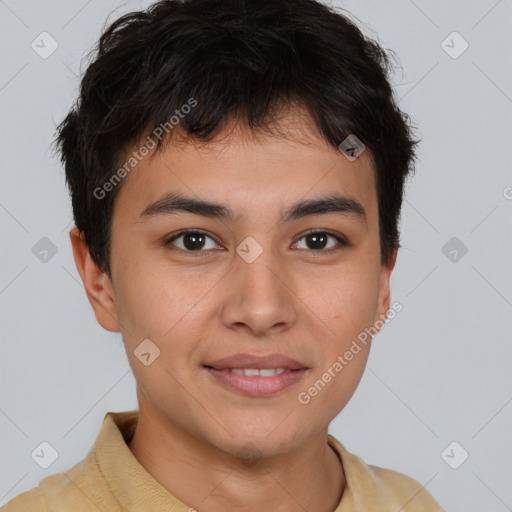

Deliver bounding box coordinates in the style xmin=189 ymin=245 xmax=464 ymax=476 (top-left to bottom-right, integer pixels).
xmin=203 ymin=367 xmax=306 ymax=396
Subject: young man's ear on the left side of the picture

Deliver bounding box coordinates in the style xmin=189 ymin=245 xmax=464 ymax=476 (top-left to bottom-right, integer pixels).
xmin=69 ymin=226 xmax=120 ymax=332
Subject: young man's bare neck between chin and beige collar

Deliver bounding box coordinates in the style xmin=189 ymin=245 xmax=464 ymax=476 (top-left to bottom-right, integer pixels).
xmin=128 ymin=410 xmax=345 ymax=512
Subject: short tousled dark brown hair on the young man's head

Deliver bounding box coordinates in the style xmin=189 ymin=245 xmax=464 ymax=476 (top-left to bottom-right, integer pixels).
xmin=55 ymin=0 xmax=419 ymax=276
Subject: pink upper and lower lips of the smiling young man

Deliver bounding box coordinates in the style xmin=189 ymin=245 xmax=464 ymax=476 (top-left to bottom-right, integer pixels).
xmin=203 ymin=354 xmax=308 ymax=396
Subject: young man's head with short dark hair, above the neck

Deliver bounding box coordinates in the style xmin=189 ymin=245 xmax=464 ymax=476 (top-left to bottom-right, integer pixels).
xmin=56 ymin=0 xmax=418 ymax=455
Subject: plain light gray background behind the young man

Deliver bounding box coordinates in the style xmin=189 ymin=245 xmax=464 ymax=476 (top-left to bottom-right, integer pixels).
xmin=0 ymin=0 xmax=512 ymax=512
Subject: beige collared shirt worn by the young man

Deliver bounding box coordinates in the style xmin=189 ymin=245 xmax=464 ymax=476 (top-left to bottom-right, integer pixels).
xmin=1 ymin=411 xmax=444 ymax=512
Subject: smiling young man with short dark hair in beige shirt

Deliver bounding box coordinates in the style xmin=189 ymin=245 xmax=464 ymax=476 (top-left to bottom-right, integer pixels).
xmin=1 ymin=0 xmax=441 ymax=512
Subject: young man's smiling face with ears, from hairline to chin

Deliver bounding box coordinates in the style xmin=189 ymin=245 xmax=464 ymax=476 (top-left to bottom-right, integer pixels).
xmin=71 ymin=107 xmax=394 ymax=455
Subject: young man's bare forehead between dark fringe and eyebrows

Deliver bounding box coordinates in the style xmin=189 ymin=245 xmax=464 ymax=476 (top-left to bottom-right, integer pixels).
xmin=115 ymin=109 xmax=377 ymax=224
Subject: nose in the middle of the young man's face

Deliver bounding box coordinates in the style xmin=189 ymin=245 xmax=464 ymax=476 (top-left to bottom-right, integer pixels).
xmin=221 ymin=242 xmax=299 ymax=336
